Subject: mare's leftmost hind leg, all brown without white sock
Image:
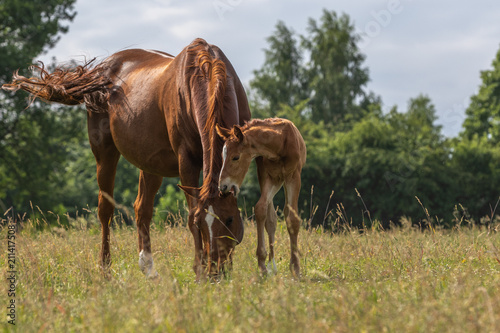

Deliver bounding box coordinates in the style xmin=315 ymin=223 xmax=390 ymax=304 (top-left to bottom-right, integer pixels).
xmin=87 ymin=112 xmax=120 ymax=271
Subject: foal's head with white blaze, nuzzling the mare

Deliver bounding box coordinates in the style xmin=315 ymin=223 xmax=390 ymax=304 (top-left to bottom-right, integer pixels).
xmin=217 ymin=125 xmax=253 ymax=196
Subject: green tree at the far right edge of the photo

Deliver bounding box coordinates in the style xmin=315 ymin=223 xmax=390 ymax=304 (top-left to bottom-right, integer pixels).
xmin=451 ymin=44 xmax=500 ymax=222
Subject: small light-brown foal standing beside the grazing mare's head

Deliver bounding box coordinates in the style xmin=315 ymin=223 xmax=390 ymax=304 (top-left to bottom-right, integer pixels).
xmin=217 ymin=118 xmax=306 ymax=276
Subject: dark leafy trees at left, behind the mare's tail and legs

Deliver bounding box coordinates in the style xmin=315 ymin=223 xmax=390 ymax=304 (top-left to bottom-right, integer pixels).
xmin=0 ymin=0 xmax=188 ymax=220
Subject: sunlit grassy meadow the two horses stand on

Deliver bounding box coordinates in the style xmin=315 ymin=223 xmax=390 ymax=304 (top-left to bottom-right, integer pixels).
xmin=0 ymin=213 xmax=500 ymax=332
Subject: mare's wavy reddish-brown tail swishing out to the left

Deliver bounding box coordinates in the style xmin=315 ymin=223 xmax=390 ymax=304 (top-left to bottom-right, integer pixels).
xmin=2 ymin=59 xmax=111 ymax=105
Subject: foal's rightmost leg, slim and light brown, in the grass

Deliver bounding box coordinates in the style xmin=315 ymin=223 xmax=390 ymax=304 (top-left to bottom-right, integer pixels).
xmin=285 ymin=172 xmax=301 ymax=277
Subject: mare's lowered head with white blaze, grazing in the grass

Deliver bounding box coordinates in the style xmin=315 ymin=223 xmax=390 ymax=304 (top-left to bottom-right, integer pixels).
xmin=179 ymin=186 xmax=244 ymax=277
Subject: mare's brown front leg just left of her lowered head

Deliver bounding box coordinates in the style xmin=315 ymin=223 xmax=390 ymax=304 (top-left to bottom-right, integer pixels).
xmin=179 ymin=152 xmax=203 ymax=281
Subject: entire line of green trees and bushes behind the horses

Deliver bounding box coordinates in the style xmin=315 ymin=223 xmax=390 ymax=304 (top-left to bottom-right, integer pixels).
xmin=0 ymin=0 xmax=500 ymax=227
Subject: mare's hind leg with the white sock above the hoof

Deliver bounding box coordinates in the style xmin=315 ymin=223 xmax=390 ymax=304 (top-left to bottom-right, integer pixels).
xmin=134 ymin=170 xmax=163 ymax=278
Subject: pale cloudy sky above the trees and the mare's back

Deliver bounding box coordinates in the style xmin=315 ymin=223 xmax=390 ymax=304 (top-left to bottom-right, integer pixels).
xmin=39 ymin=0 xmax=500 ymax=137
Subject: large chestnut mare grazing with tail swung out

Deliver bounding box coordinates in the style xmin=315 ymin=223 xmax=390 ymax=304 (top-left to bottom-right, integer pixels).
xmin=3 ymin=39 xmax=250 ymax=279
